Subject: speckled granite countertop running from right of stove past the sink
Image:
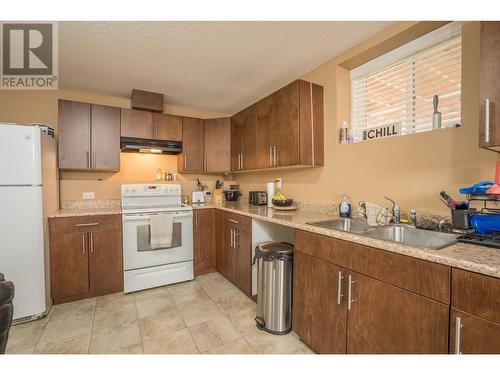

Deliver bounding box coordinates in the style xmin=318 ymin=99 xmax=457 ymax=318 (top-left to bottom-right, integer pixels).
xmin=193 ymin=202 xmax=500 ymax=278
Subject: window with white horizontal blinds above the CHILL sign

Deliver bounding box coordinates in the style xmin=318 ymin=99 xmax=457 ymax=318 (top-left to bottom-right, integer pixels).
xmin=351 ymin=22 xmax=462 ymax=142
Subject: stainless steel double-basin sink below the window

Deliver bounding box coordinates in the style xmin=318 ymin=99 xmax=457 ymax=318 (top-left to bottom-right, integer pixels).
xmin=307 ymin=219 xmax=457 ymax=250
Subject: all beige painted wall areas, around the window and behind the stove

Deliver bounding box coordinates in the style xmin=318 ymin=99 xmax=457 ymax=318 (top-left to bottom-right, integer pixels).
xmin=0 ymin=22 xmax=498 ymax=214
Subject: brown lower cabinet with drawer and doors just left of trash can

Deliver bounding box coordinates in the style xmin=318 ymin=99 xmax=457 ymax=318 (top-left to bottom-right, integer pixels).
xmin=216 ymin=211 xmax=252 ymax=296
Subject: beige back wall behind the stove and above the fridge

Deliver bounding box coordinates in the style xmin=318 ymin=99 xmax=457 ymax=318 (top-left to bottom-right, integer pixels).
xmin=0 ymin=90 xmax=227 ymax=200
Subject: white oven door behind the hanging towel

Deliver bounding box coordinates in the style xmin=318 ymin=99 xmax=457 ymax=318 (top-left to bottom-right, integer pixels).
xmin=122 ymin=211 xmax=193 ymax=271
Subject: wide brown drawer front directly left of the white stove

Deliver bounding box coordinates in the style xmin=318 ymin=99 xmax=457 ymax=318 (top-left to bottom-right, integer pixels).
xmin=49 ymin=215 xmax=121 ymax=234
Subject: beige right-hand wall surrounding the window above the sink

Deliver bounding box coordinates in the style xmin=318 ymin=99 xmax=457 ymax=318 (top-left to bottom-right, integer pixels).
xmin=238 ymin=23 xmax=499 ymax=214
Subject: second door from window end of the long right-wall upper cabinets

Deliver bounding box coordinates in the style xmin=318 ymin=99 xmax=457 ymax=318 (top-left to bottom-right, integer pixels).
xmin=255 ymin=94 xmax=276 ymax=168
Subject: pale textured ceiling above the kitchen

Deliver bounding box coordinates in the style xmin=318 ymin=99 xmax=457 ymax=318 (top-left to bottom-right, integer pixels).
xmin=59 ymin=22 xmax=391 ymax=113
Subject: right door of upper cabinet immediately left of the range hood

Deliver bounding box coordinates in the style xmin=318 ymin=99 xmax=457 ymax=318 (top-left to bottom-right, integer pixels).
xmin=91 ymin=104 xmax=120 ymax=171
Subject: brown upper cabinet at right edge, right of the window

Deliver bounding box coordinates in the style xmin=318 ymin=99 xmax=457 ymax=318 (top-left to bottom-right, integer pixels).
xmin=479 ymin=21 xmax=500 ymax=151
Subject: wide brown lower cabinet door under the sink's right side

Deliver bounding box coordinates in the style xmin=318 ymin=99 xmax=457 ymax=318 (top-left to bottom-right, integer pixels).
xmin=347 ymin=272 xmax=449 ymax=354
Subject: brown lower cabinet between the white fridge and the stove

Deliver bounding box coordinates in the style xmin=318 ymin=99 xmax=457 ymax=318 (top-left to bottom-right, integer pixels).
xmin=49 ymin=215 xmax=123 ymax=304
